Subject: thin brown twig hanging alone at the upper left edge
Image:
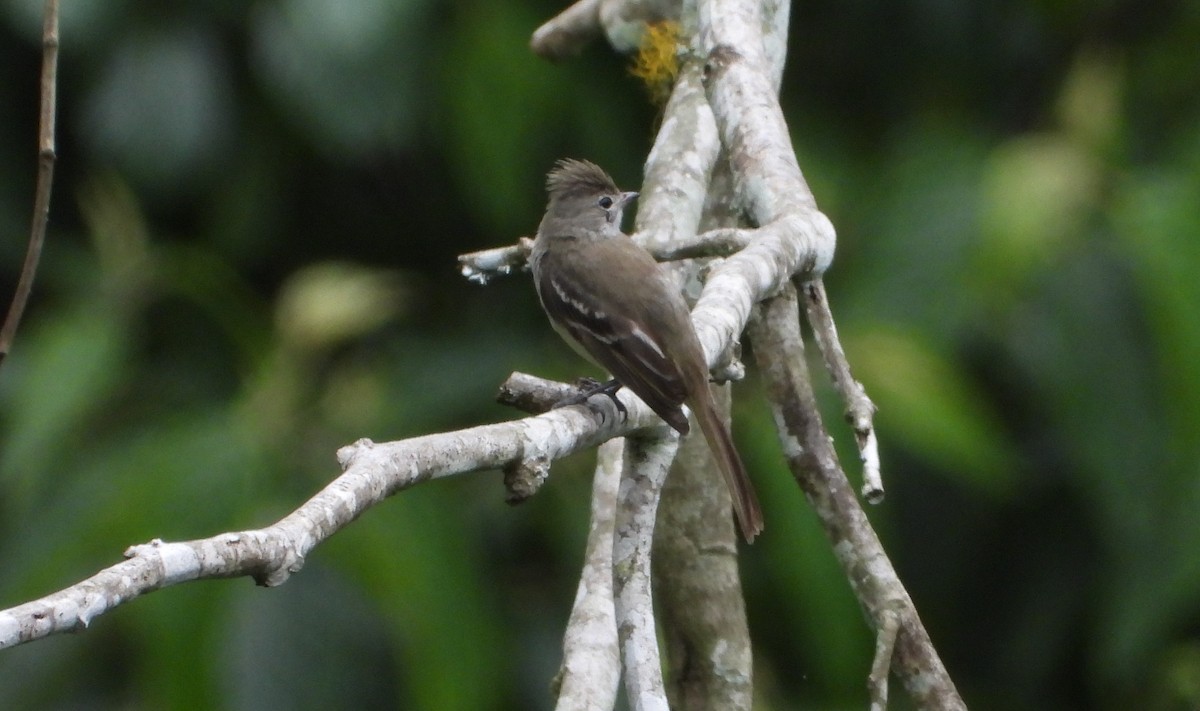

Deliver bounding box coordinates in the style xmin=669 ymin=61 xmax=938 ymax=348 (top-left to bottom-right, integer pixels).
xmin=0 ymin=0 xmax=59 ymax=363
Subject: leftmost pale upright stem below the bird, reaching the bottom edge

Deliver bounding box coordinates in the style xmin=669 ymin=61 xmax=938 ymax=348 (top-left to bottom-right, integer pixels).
xmin=554 ymin=438 xmax=625 ymax=711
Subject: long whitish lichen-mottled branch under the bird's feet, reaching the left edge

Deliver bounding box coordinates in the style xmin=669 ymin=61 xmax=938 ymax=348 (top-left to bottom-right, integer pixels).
xmin=0 ymin=378 xmax=660 ymax=649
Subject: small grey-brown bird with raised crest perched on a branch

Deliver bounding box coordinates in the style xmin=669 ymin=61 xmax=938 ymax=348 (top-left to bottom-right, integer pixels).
xmin=530 ymin=160 xmax=762 ymax=542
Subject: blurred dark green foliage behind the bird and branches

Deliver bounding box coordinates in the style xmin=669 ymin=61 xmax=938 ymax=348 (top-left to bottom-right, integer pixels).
xmin=0 ymin=0 xmax=1200 ymax=711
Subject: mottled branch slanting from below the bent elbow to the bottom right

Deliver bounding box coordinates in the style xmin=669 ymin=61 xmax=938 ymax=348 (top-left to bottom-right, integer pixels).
xmin=749 ymin=285 xmax=966 ymax=710
